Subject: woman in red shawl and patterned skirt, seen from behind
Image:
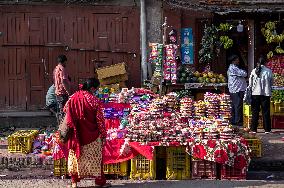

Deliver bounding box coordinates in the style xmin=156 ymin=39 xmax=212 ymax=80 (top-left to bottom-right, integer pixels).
xmin=64 ymin=78 xmax=106 ymax=188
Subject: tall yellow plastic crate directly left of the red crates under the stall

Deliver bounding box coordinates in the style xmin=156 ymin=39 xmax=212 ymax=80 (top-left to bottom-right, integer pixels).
xmin=166 ymin=147 xmax=190 ymax=180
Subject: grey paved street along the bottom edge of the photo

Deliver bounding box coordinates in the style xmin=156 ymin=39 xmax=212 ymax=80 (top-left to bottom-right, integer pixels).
xmin=0 ymin=179 xmax=284 ymax=188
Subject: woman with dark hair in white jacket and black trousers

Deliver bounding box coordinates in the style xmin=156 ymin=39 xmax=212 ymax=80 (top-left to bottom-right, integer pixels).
xmin=249 ymin=56 xmax=273 ymax=134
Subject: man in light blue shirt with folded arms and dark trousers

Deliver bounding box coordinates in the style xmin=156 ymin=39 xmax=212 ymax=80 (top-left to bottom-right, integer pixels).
xmin=227 ymin=55 xmax=247 ymax=126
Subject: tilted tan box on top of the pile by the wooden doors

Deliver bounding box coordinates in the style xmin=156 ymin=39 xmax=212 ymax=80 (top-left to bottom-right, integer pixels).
xmin=97 ymin=63 xmax=127 ymax=80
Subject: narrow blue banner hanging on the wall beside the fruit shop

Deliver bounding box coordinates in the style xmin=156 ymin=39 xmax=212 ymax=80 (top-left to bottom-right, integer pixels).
xmin=181 ymin=28 xmax=194 ymax=64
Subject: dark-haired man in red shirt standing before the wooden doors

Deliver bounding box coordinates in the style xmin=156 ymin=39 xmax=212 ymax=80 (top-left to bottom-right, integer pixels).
xmin=53 ymin=55 xmax=71 ymax=122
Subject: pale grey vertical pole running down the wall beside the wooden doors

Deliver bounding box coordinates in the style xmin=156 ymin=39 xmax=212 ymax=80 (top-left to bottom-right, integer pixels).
xmin=140 ymin=0 xmax=148 ymax=82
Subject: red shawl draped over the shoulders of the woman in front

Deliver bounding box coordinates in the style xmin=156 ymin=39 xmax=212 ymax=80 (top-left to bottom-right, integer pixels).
xmin=64 ymin=90 xmax=106 ymax=158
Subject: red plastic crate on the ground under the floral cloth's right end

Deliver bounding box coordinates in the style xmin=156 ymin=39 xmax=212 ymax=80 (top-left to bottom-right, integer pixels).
xmin=221 ymin=165 xmax=247 ymax=180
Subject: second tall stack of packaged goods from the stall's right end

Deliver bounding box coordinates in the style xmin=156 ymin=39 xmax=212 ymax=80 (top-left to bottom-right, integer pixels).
xmin=204 ymin=92 xmax=220 ymax=118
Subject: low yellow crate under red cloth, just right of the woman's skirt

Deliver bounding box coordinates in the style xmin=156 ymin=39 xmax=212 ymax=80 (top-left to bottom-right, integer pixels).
xmin=103 ymin=161 xmax=127 ymax=176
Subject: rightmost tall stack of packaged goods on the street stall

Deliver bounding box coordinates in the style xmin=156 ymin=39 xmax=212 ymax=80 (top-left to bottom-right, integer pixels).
xmin=219 ymin=93 xmax=231 ymax=122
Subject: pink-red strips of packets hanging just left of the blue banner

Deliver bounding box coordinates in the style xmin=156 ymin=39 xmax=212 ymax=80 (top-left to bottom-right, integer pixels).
xmin=164 ymin=44 xmax=177 ymax=84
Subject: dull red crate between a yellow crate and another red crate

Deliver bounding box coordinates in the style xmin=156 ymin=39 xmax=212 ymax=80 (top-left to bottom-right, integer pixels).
xmin=191 ymin=159 xmax=217 ymax=179
